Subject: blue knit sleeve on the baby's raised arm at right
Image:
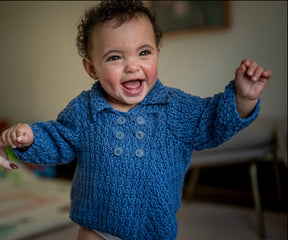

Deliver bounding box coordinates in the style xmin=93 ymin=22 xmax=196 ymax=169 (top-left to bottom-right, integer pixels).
xmin=166 ymin=81 xmax=260 ymax=151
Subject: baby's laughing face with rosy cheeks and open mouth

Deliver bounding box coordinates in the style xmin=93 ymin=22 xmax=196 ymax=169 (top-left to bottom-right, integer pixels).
xmin=89 ymin=15 xmax=160 ymax=111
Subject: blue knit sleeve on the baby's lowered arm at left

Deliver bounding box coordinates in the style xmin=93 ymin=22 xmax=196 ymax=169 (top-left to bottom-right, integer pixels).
xmin=14 ymin=92 xmax=81 ymax=165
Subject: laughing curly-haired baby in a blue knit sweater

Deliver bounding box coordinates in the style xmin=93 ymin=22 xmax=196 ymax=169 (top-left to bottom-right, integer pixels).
xmin=0 ymin=0 xmax=272 ymax=240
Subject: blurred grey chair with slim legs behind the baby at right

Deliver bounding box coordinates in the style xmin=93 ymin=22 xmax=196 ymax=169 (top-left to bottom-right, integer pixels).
xmin=185 ymin=119 xmax=287 ymax=238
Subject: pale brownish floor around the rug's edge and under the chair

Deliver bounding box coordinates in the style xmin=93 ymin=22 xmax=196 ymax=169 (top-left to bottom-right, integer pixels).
xmin=27 ymin=201 xmax=287 ymax=240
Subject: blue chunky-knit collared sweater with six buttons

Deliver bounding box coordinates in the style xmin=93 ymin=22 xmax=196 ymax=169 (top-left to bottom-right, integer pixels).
xmin=15 ymin=80 xmax=259 ymax=240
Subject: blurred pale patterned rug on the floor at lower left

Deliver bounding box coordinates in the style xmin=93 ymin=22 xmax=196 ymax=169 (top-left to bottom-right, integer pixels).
xmin=0 ymin=150 xmax=71 ymax=240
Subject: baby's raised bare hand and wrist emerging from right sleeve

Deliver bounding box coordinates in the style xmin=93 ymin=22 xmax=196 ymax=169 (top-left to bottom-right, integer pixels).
xmin=235 ymin=59 xmax=272 ymax=118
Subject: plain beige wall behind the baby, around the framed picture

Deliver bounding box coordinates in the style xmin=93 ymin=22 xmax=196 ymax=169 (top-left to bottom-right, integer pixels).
xmin=0 ymin=1 xmax=287 ymax=123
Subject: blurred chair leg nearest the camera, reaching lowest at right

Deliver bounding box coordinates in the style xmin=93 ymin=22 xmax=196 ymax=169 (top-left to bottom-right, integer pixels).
xmin=249 ymin=162 xmax=265 ymax=238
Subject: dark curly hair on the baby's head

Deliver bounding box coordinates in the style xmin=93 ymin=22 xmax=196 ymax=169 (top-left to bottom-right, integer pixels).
xmin=77 ymin=0 xmax=162 ymax=57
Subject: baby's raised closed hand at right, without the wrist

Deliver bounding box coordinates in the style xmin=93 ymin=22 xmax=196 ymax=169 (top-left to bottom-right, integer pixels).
xmin=235 ymin=59 xmax=272 ymax=101
